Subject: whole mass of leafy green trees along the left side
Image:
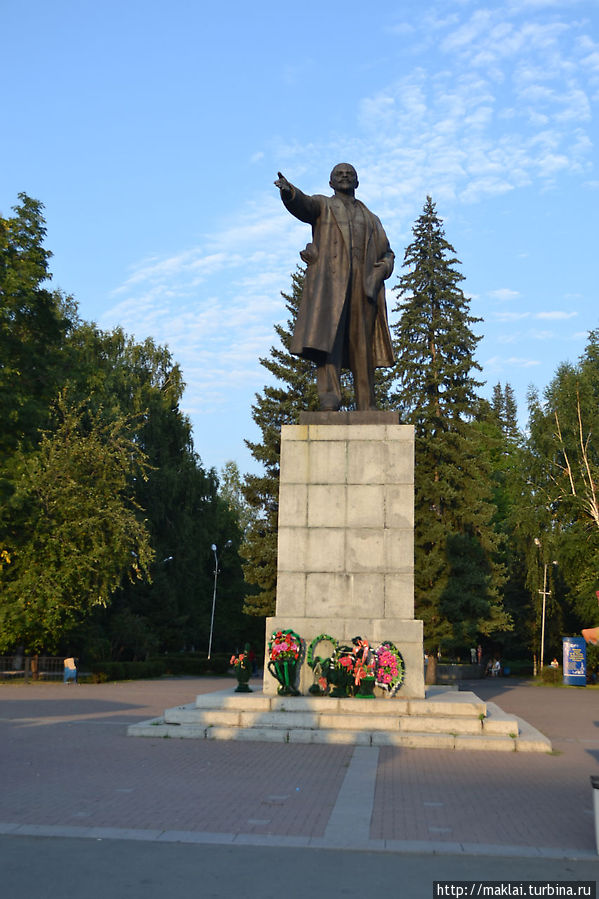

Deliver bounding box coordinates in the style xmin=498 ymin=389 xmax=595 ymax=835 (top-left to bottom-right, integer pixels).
xmin=0 ymin=194 xmax=259 ymax=659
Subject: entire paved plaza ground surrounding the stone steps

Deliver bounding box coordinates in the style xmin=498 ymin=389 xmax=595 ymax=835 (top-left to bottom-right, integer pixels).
xmin=0 ymin=678 xmax=599 ymax=899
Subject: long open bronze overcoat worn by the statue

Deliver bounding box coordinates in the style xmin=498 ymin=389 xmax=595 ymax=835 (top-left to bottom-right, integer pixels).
xmin=283 ymin=187 xmax=395 ymax=368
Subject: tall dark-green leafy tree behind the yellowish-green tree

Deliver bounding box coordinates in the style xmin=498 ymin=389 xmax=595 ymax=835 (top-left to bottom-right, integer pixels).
xmin=61 ymin=325 xmax=254 ymax=659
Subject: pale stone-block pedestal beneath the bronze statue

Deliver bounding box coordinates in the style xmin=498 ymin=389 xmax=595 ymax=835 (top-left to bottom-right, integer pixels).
xmin=264 ymin=412 xmax=424 ymax=698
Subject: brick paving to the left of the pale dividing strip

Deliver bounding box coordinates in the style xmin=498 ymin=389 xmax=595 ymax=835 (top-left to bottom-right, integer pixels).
xmin=0 ymin=680 xmax=352 ymax=836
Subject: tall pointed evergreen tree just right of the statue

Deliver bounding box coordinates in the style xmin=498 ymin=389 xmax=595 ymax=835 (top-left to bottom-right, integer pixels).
xmin=390 ymin=197 xmax=509 ymax=649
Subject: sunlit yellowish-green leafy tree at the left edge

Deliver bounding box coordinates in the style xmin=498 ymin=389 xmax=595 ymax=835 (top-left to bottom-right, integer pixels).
xmin=0 ymin=391 xmax=153 ymax=651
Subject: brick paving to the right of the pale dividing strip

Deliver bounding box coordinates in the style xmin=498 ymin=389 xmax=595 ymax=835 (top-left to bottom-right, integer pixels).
xmin=371 ymin=679 xmax=599 ymax=851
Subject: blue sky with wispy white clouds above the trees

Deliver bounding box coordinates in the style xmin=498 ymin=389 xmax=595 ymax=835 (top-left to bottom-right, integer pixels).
xmin=0 ymin=0 xmax=599 ymax=471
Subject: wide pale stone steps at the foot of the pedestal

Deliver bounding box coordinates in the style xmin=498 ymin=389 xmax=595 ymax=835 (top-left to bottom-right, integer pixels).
xmin=127 ymin=690 xmax=551 ymax=752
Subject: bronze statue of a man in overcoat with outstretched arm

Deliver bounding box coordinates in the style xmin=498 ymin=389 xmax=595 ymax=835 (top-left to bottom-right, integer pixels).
xmin=275 ymin=162 xmax=395 ymax=411
